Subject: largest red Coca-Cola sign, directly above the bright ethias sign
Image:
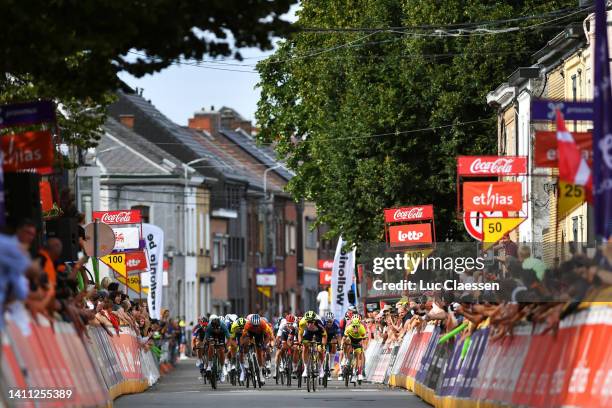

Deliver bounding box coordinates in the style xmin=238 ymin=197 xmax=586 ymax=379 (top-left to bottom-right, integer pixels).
xmin=457 ymin=156 xmax=527 ymax=177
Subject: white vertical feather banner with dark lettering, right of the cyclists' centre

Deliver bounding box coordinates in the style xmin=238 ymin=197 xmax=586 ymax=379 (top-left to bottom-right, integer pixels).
xmin=331 ymin=237 xmax=355 ymax=319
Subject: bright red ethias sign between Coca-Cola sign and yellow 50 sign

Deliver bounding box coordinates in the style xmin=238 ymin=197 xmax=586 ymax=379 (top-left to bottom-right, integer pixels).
xmin=463 ymin=181 xmax=523 ymax=212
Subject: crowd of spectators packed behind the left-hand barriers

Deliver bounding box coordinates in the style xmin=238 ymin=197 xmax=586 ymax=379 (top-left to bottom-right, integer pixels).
xmin=0 ymin=220 xmax=184 ymax=362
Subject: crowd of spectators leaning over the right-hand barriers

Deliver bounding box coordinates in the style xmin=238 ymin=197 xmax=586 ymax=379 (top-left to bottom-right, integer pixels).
xmin=365 ymin=238 xmax=612 ymax=348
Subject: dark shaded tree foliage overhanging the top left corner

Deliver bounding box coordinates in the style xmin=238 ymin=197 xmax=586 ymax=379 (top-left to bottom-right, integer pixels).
xmin=0 ymin=0 xmax=296 ymax=98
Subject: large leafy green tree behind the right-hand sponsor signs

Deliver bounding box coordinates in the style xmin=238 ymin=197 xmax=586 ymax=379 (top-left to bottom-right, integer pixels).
xmin=257 ymin=0 xmax=586 ymax=242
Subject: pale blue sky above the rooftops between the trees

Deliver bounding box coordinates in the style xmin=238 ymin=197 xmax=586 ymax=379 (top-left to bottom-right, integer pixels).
xmin=119 ymin=5 xmax=299 ymax=125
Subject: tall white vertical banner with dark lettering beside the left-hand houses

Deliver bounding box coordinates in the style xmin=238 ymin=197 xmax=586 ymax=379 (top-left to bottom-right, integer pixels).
xmin=142 ymin=224 xmax=164 ymax=319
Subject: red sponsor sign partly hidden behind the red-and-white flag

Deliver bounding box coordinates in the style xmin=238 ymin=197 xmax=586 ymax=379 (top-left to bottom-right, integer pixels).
xmin=535 ymin=131 xmax=593 ymax=168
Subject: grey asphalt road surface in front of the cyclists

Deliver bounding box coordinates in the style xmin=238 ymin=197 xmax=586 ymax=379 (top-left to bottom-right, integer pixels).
xmin=115 ymin=360 xmax=429 ymax=408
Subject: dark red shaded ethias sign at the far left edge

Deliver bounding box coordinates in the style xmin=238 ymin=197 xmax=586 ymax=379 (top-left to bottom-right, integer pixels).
xmin=0 ymin=130 xmax=55 ymax=172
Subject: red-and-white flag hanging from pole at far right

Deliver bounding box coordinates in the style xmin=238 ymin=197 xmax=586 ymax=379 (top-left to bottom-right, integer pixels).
xmin=557 ymin=110 xmax=593 ymax=199
